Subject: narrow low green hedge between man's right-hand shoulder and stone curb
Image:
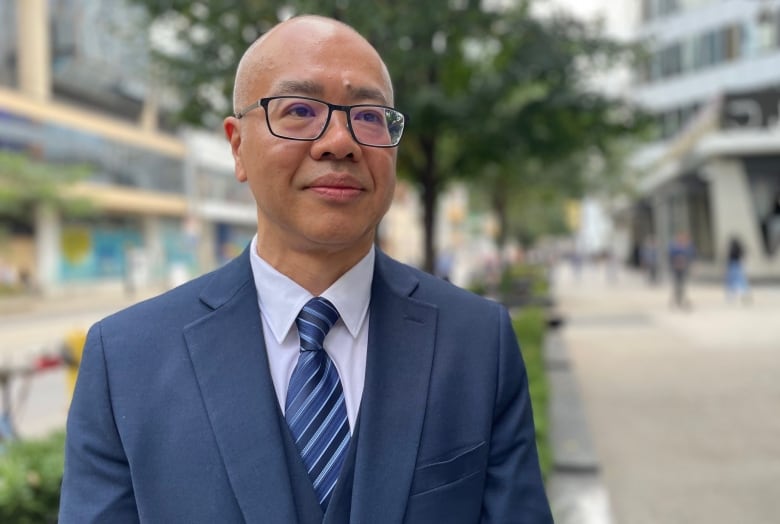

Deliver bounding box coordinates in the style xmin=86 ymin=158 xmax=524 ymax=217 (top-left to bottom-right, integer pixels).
xmin=512 ymin=307 xmax=553 ymax=484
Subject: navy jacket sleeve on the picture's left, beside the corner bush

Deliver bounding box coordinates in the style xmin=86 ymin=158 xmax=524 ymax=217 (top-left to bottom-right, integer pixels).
xmin=58 ymin=324 xmax=139 ymax=524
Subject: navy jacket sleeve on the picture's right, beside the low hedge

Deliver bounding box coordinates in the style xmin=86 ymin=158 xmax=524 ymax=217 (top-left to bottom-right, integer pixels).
xmin=481 ymin=308 xmax=553 ymax=524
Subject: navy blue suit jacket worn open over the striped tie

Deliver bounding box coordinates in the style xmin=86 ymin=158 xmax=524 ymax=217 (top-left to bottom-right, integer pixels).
xmin=60 ymin=251 xmax=552 ymax=524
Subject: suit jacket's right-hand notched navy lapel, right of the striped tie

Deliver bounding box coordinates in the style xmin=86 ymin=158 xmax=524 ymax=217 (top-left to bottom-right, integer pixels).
xmin=352 ymin=252 xmax=437 ymax=522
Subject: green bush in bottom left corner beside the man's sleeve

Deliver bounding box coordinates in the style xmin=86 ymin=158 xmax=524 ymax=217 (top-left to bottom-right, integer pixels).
xmin=0 ymin=432 xmax=65 ymax=524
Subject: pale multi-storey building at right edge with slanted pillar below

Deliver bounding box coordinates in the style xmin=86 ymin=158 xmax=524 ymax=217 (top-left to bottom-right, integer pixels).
xmin=631 ymin=0 xmax=780 ymax=281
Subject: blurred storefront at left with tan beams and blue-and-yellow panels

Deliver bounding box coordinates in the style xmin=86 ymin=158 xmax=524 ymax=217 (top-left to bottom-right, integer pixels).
xmin=0 ymin=101 xmax=187 ymax=293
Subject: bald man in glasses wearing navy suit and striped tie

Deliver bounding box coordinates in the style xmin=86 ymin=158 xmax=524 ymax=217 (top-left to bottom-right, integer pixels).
xmin=60 ymin=16 xmax=552 ymax=524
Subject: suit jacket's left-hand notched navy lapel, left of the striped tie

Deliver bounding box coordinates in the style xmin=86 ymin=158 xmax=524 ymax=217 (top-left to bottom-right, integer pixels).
xmin=184 ymin=252 xmax=296 ymax=522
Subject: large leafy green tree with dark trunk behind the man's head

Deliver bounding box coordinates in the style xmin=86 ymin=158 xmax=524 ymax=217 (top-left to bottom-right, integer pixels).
xmin=130 ymin=0 xmax=652 ymax=271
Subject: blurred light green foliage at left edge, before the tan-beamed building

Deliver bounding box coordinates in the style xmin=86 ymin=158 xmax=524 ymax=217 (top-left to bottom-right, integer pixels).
xmin=0 ymin=150 xmax=91 ymax=220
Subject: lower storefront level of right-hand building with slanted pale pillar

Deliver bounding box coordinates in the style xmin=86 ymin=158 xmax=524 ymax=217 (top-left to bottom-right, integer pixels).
xmin=633 ymin=89 xmax=780 ymax=282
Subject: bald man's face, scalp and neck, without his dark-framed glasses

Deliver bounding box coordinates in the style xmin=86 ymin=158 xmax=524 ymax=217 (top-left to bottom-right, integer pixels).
xmin=225 ymin=22 xmax=396 ymax=263
